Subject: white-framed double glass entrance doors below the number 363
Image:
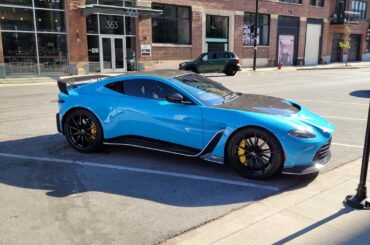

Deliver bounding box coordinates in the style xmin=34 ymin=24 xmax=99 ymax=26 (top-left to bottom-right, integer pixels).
xmin=100 ymin=35 xmax=126 ymax=72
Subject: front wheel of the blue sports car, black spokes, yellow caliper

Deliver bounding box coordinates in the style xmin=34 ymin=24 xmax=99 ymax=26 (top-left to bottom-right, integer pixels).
xmin=226 ymin=128 xmax=284 ymax=179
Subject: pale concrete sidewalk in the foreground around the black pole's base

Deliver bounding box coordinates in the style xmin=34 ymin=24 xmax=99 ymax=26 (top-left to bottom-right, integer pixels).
xmin=165 ymin=160 xmax=370 ymax=245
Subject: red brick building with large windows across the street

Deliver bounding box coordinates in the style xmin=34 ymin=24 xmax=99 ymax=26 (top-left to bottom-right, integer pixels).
xmin=0 ymin=0 xmax=370 ymax=76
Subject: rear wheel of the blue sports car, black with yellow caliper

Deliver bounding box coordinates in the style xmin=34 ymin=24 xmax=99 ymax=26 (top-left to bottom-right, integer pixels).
xmin=63 ymin=109 xmax=103 ymax=153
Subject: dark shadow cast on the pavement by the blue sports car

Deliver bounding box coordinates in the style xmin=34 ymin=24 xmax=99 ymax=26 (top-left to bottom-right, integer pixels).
xmin=0 ymin=134 xmax=317 ymax=207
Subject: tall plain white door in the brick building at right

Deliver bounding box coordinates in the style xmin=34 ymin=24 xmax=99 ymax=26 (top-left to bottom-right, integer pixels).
xmin=304 ymin=24 xmax=321 ymax=65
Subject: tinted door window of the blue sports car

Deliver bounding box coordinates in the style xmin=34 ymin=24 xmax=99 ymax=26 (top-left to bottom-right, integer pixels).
xmin=124 ymin=79 xmax=177 ymax=100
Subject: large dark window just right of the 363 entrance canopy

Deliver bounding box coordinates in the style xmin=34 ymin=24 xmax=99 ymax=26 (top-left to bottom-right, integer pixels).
xmin=152 ymin=3 xmax=191 ymax=44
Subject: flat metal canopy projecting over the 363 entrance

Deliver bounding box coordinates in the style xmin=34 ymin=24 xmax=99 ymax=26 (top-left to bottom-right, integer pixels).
xmin=78 ymin=4 xmax=163 ymax=19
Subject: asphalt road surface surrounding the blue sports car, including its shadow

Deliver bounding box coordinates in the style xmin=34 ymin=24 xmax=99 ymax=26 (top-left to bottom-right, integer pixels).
xmin=0 ymin=69 xmax=370 ymax=244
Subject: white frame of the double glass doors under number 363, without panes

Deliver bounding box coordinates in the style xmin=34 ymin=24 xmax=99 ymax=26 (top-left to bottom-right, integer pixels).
xmin=99 ymin=34 xmax=127 ymax=73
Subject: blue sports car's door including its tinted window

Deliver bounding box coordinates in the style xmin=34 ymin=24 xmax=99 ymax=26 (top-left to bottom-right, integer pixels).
xmin=116 ymin=78 xmax=204 ymax=149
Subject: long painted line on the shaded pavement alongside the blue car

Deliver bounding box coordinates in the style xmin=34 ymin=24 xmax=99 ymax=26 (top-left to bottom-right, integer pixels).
xmin=0 ymin=153 xmax=280 ymax=191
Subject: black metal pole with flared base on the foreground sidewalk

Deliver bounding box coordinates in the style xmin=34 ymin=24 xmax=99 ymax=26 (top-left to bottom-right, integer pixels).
xmin=345 ymin=104 xmax=370 ymax=209
